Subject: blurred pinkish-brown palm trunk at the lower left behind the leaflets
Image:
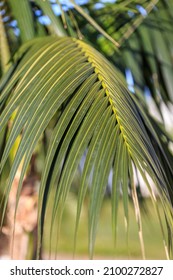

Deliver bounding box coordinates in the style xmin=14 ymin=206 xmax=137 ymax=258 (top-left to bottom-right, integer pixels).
xmin=0 ymin=170 xmax=38 ymax=260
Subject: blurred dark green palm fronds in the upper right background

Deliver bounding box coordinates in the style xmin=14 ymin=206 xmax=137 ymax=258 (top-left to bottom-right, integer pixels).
xmin=74 ymin=0 xmax=173 ymax=108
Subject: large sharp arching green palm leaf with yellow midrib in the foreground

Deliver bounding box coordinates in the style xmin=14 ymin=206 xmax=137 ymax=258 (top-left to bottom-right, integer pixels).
xmin=0 ymin=37 xmax=173 ymax=256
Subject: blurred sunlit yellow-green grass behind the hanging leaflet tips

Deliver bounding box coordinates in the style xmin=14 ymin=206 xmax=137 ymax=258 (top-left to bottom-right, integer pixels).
xmin=44 ymin=194 xmax=166 ymax=259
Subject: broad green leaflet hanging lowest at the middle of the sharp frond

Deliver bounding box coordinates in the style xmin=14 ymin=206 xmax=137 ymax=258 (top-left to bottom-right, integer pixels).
xmin=89 ymin=117 xmax=116 ymax=258
